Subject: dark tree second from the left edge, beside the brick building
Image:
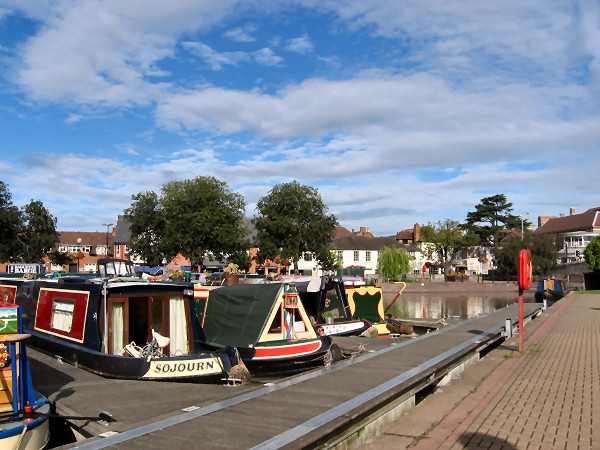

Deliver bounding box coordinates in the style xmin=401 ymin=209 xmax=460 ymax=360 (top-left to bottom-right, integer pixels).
xmin=18 ymin=200 xmax=59 ymax=263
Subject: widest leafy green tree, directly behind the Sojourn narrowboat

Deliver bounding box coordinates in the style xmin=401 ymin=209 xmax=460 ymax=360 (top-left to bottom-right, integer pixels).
xmin=125 ymin=176 xmax=249 ymax=268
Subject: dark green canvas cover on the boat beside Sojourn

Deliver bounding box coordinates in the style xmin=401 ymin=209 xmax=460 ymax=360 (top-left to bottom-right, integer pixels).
xmin=203 ymin=283 xmax=283 ymax=347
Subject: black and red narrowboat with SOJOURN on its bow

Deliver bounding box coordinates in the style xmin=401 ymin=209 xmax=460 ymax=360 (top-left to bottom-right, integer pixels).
xmin=0 ymin=268 xmax=247 ymax=382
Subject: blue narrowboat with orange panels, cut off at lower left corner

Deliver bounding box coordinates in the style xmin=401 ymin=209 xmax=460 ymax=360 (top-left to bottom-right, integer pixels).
xmin=0 ymin=303 xmax=50 ymax=450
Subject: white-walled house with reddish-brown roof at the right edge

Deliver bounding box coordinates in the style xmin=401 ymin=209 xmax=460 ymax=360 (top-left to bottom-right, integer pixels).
xmin=534 ymin=207 xmax=600 ymax=262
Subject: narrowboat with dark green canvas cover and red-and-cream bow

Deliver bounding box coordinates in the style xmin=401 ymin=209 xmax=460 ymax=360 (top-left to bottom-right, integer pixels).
xmin=196 ymin=282 xmax=341 ymax=375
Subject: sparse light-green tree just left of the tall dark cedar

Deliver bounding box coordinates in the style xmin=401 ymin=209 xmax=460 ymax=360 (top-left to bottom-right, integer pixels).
xmin=421 ymin=219 xmax=479 ymax=273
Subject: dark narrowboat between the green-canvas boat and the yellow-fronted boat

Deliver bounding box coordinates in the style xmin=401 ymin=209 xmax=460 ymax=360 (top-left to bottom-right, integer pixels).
xmin=282 ymin=276 xmax=371 ymax=336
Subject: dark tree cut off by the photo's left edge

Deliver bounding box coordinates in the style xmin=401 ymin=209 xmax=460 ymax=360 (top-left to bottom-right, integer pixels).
xmin=0 ymin=181 xmax=23 ymax=262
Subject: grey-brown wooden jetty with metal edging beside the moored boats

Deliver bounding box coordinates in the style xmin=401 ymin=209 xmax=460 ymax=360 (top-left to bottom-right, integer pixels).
xmin=30 ymin=303 xmax=542 ymax=448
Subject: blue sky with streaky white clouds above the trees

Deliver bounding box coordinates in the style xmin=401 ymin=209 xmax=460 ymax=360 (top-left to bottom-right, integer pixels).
xmin=0 ymin=0 xmax=600 ymax=236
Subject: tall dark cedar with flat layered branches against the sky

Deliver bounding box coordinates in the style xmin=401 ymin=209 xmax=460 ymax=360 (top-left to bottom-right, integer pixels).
xmin=464 ymin=194 xmax=530 ymax=247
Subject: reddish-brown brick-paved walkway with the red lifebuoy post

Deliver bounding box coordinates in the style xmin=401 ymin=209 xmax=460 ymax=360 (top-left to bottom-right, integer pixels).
xmin=363 ymin=294 xmax=600 ymax=450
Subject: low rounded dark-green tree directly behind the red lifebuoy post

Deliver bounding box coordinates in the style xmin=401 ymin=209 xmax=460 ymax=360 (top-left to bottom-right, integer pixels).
xmin=494 ymin=232 xmax=558 ymax=276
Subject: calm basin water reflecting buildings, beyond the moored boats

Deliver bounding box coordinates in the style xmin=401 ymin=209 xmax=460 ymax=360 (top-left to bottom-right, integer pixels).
xmin=383 ymin=292 xmax=535 ymax=320
